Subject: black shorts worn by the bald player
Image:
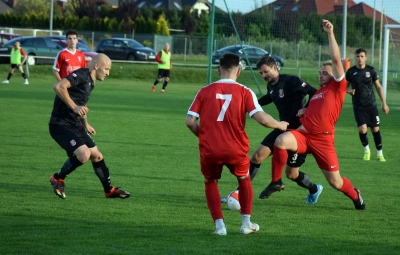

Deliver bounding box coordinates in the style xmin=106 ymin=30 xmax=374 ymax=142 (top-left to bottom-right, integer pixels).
xmin=49 ymin=124 xmax=96 ymax=157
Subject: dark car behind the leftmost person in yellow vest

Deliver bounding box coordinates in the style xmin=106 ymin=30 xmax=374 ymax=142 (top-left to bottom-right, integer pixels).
xmin=0 ymin=36 xmax=62 ymax=65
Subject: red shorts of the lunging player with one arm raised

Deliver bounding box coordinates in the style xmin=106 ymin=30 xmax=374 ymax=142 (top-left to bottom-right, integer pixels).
xmin=289 ymin=130 xmax=339 ymax=171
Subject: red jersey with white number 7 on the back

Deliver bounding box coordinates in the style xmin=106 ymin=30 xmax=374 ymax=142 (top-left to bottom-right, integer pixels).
xmin=188 ymin=79 xmax=263 ymax=164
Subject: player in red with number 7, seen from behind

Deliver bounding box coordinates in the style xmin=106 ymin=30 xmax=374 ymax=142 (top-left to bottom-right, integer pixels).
xmin=186 ymin=53 xmax=288 ymax=235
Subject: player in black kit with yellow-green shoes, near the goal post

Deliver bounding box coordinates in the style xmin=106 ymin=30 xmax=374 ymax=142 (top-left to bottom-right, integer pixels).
xmin=346 ymin=48 xmax=389 ymax=162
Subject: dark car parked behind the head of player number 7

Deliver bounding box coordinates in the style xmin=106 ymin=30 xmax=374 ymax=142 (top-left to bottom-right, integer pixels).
xmin=212 ymin=45 xmax=284 ymax=70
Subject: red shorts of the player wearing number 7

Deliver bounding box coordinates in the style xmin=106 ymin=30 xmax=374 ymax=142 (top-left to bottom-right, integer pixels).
xmin=200 ymin=157 xmax=250 ymax=180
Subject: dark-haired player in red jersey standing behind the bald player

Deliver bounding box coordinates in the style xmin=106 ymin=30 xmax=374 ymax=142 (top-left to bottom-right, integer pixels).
xmin=53 ymin=29 xmax=86 ymax=81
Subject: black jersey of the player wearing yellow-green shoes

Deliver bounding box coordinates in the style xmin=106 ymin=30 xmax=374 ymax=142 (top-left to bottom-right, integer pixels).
xmin=346 ymin=65 xmax=379 ymax=107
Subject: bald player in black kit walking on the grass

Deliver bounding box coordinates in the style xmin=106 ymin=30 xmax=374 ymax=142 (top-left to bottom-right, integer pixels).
xmin=49 ymin=53 xmax=130 ymax=199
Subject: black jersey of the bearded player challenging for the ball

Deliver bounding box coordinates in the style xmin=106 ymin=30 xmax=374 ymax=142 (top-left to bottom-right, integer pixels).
xmin=258 ymin=74 xmax=317 ymax=128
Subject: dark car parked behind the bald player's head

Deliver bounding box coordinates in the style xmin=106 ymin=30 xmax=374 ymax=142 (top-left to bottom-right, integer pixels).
xmin=96 ymin=38 xmax=157 ymax=61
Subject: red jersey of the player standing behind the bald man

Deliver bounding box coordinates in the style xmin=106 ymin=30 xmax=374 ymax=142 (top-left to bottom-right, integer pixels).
xmin=53 ymin=48 xmax=86 ymax=79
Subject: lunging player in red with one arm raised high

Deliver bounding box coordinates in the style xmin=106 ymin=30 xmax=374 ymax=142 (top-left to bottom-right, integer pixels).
xmin=272 ymin=20 xmax=365 ymax=210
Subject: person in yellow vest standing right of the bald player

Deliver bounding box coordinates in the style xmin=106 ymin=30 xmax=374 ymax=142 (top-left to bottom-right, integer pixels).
xmin=151 ymin=43 xmax=172 ymax=94
